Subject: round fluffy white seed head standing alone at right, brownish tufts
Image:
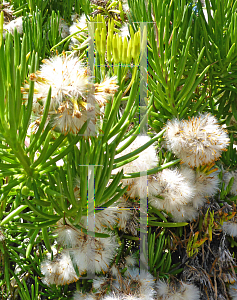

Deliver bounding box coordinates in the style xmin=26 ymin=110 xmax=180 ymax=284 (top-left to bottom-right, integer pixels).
xmin=164 ymin=114 xmax=229 ymax=167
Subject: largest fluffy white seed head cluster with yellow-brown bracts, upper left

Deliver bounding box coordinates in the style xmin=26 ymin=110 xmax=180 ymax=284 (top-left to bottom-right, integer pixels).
xmin=27 ymin=56 xmax=117 ymax=134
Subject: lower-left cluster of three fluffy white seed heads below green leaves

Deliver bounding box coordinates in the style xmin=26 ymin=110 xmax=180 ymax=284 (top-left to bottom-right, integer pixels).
xmin=41 ymin=220 xmax=118 ymax=285
